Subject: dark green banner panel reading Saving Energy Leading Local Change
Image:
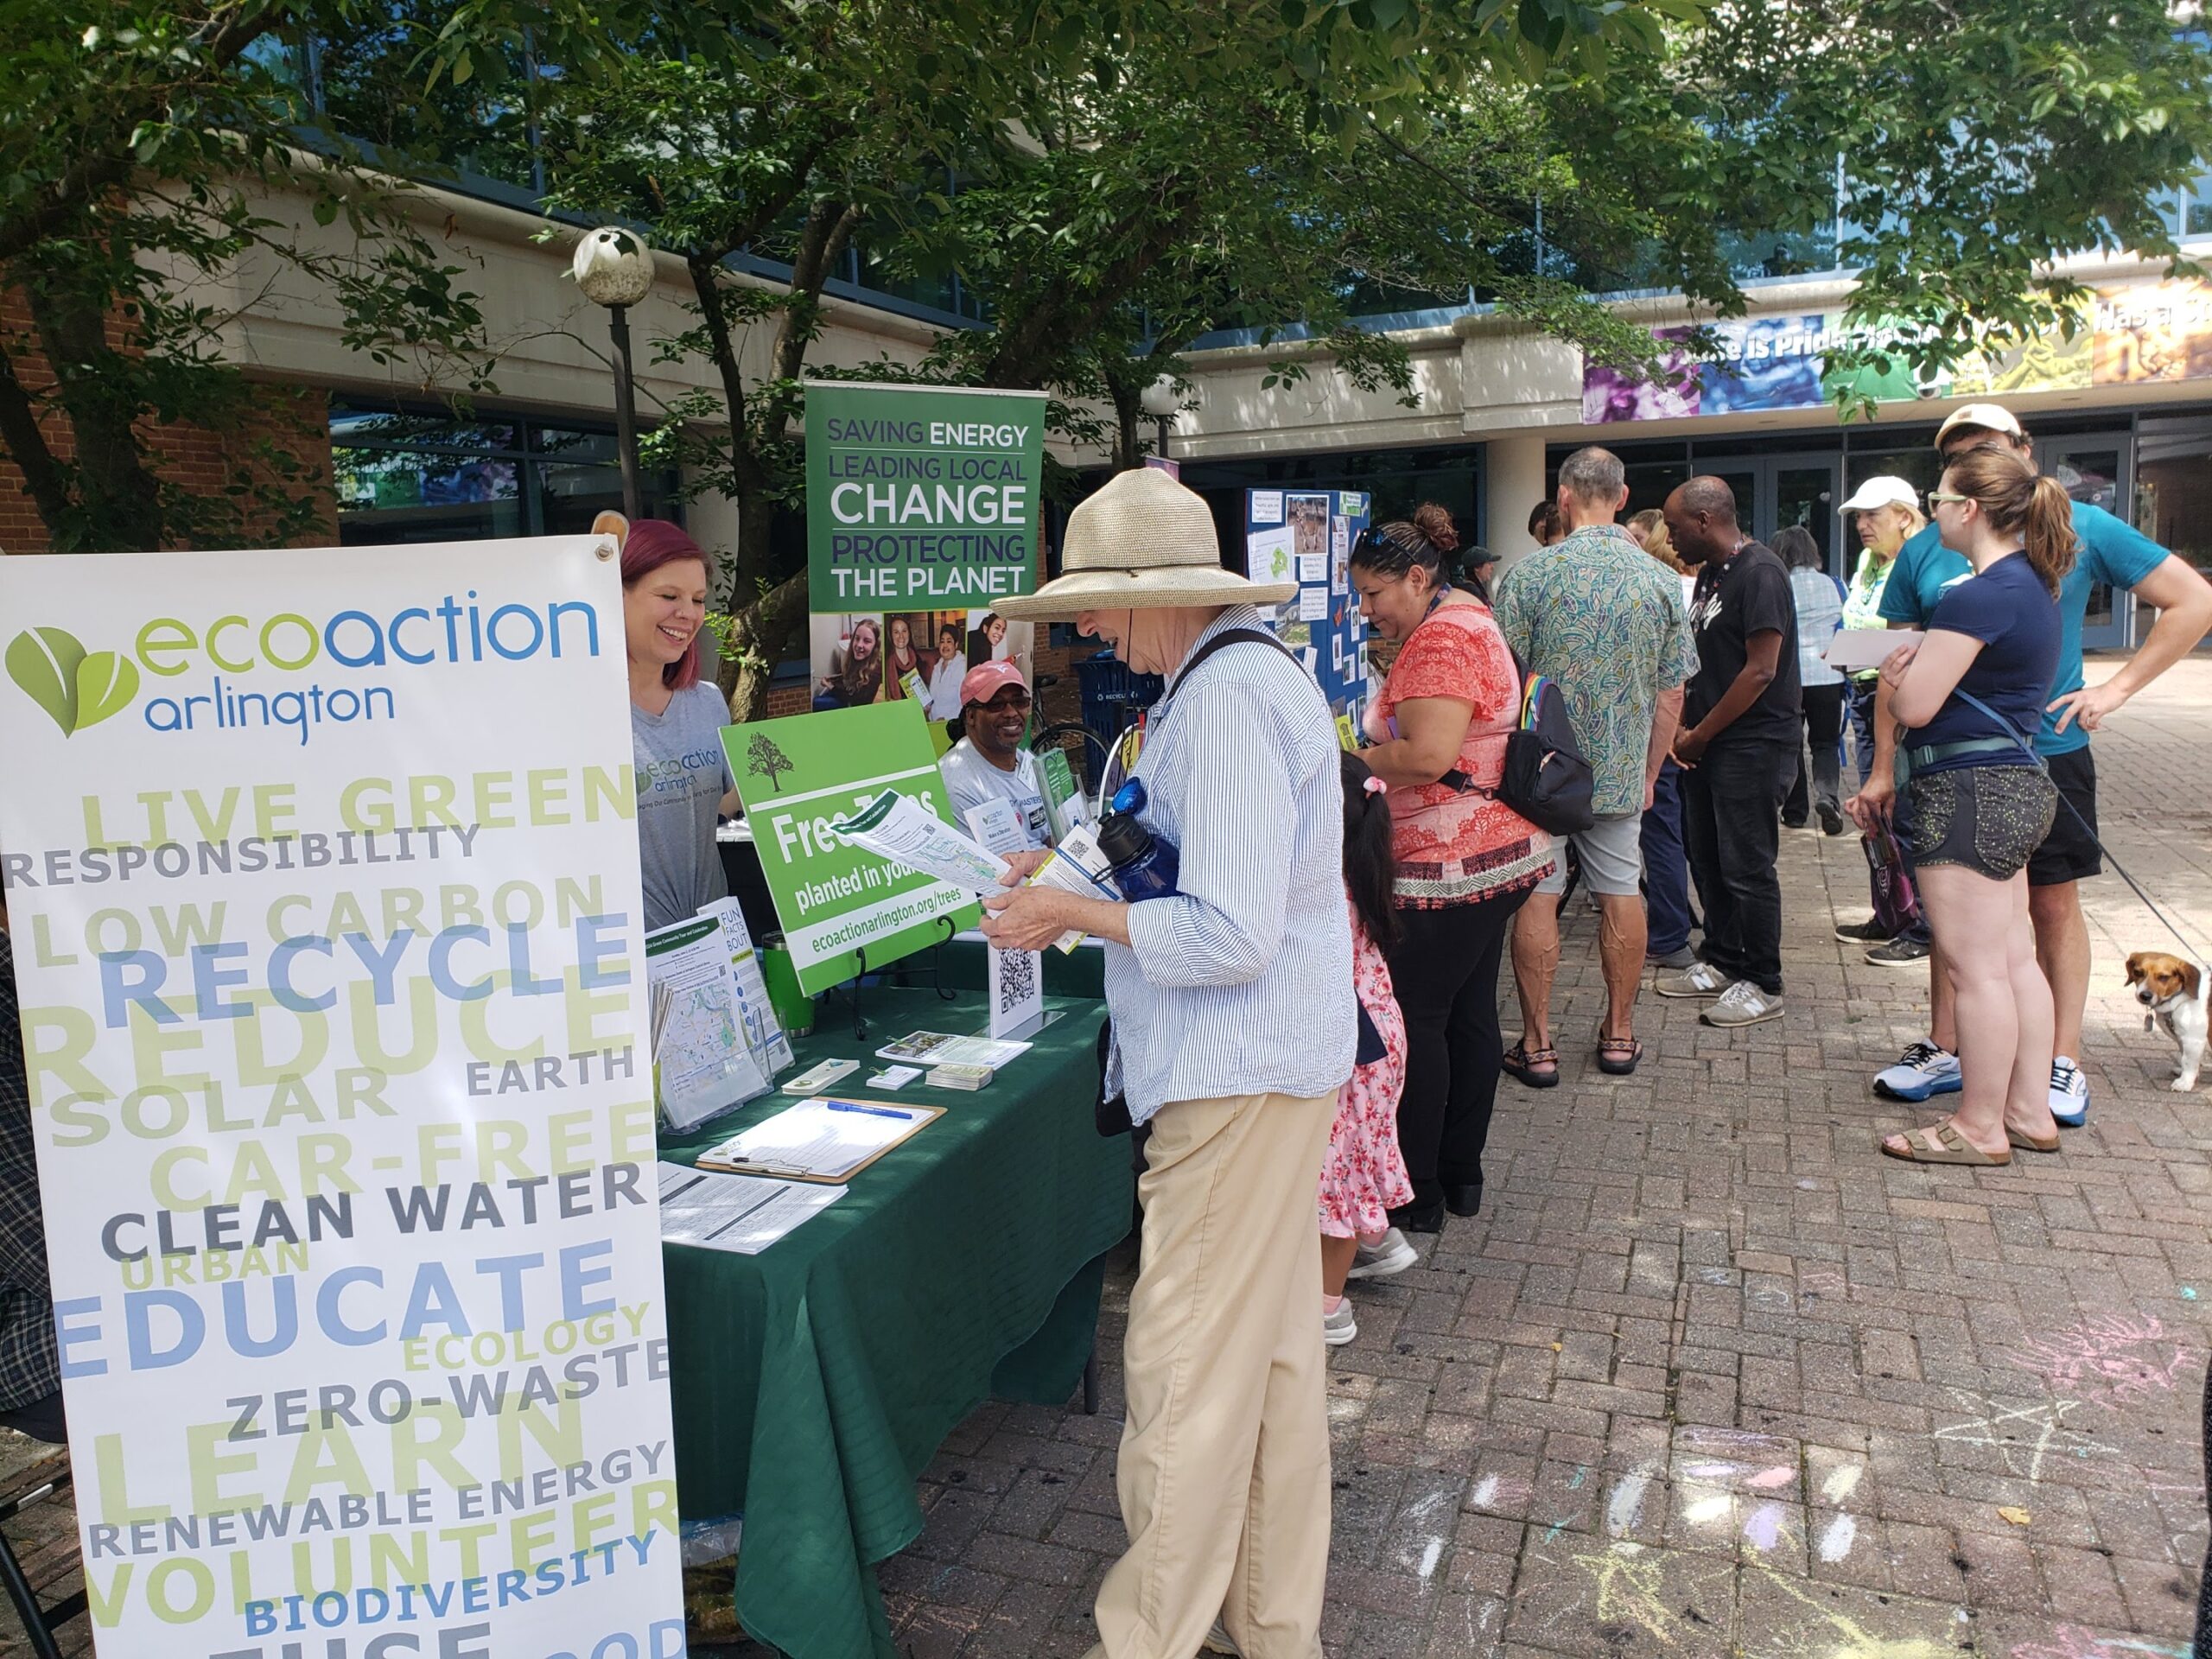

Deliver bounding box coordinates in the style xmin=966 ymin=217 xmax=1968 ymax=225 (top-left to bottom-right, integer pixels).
xmin=807 ymin=380 xmax=1044 ymax=613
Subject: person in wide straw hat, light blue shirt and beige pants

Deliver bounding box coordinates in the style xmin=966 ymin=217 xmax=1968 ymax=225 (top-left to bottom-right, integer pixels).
xmin=984 ymin=469 xmax=1356 ymax=1659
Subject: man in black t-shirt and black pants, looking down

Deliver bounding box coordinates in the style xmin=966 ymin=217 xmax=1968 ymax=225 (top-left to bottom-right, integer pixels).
xmin=1652 ymin=478 xmax=1801 ymax=1027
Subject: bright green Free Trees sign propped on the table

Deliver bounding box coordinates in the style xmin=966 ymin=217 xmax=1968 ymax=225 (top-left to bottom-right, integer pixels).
xmin=721 ymin=702 xmax=980 ymax=995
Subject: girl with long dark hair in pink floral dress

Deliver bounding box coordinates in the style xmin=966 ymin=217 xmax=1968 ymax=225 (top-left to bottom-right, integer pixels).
xmin=1320 ymin=754 xmax=1415 ymax=1347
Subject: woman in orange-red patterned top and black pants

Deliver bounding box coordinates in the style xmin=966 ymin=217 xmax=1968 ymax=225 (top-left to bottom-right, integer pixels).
xmin=1351 ymin=505 xmax=1551 ymax=1232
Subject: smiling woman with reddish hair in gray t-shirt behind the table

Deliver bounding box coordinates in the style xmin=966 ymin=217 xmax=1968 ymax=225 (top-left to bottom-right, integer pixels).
xmin=621 ymin=518 xmax=739 ymax=929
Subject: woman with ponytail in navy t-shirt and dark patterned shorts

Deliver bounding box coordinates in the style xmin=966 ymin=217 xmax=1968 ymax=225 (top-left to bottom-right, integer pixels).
xmin=1883 ymin=449 xmax=2079 ymax=1164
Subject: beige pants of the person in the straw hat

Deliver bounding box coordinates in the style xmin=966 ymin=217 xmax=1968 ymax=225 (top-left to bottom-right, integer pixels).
xmin=1093 ymin=1095 xmax=1336 ymax=1659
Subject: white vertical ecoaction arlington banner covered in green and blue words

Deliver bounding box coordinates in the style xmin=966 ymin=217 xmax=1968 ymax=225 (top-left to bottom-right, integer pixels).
xmin=0 ymin=536 xmax=683 ymax=1659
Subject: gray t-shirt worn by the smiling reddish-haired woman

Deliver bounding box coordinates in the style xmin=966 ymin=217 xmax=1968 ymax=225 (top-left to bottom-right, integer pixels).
xmin=631 ymin=681 xmax=736 ymax=929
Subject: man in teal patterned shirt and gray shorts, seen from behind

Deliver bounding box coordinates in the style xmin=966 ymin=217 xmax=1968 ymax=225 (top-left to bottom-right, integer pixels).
xmin=1496 ymin=447 xmax=1697 ymax=1089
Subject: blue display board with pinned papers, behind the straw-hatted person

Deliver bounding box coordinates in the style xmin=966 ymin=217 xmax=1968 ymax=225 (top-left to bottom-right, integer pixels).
xmin=1245 ymin=489 xmax=1374 ymax=728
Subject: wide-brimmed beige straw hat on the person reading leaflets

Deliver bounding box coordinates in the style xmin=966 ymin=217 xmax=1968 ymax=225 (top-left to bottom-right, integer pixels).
xmin=991 ymin=467 xmax=1299 ymax=617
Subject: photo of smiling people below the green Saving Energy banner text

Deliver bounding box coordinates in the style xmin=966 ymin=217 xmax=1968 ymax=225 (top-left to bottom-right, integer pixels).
xmin=807 ymin=611 xmax=1038 ymax=721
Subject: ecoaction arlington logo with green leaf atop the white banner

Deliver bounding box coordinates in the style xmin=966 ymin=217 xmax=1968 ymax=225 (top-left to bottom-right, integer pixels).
xmin=7 ymin=588 xmax=600 ymax=746
